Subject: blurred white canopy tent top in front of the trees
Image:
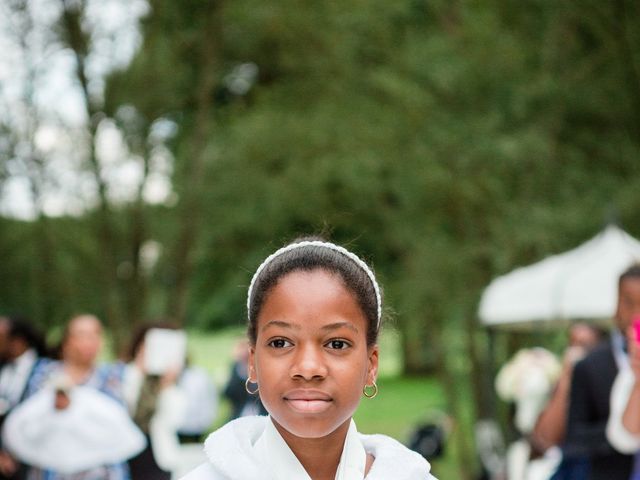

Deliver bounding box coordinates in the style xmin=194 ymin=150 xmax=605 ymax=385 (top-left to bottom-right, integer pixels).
xmin=479 ymin=225 xmax=640 ymax=327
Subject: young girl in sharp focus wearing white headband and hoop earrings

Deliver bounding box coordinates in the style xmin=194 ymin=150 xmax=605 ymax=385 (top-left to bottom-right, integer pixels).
xmin=184 ymin=240 xmax=435 ymax=480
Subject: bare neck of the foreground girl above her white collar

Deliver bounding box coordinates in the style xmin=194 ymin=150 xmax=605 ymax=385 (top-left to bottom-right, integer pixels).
xmin=274 ymin=419 xmax=351 ymax=480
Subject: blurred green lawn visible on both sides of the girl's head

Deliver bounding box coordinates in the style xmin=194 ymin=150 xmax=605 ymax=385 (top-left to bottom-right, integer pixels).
xmin=189 ymin=328 xmax=458 ymax=478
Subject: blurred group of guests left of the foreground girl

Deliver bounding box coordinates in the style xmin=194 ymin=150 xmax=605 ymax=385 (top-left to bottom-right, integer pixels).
xmin=0 ymin=314 xmax=263 ymax=480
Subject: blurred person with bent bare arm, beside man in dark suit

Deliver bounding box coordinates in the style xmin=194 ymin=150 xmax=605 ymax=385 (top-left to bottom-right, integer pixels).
xmin=531 ymin=322 xmax=606 ymax=480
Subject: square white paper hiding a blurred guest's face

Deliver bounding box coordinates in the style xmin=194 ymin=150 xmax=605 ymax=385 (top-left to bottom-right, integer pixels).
xmin=144 ymin=328 xmax=187 ymax=375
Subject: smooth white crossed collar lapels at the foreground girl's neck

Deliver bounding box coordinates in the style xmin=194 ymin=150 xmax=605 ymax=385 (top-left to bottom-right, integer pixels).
xmin=254 ymin=417 xmax=367 ymax=480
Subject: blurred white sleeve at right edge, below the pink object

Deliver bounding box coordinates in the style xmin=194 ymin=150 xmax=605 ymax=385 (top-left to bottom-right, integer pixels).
xmin=607 ymin=367 xmax=640 ymax=454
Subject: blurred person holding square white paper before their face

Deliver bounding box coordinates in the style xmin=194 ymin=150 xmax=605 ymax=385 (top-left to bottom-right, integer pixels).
xmin=123 ymin=322 xmax=208 ymax=480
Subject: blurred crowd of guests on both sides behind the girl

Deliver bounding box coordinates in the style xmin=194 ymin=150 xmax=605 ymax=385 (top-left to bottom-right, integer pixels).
xmin=7 ymin=264 xmax=640 ymax=480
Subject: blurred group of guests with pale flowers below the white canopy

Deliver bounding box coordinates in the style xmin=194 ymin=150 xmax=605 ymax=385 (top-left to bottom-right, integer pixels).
xmin=496 ymin=264 xmax=640 ymax=480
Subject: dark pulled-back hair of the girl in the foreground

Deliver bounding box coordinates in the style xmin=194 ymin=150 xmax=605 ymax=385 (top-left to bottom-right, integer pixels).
xmin=247 ymin=237 xmax=379 ymax=346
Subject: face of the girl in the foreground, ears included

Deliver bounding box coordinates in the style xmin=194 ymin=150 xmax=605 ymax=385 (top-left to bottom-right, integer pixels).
xmin=249 ymin=269 xmax=378 ymax=438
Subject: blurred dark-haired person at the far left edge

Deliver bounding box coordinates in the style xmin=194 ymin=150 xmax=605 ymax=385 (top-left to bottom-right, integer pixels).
xmin=0 ymin=317 xmax=47 ymax=480
